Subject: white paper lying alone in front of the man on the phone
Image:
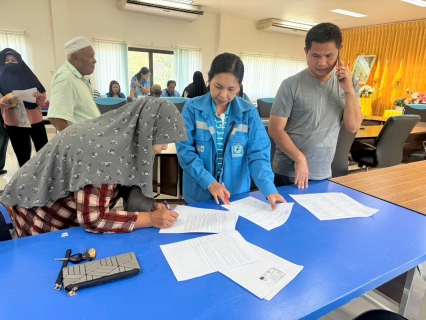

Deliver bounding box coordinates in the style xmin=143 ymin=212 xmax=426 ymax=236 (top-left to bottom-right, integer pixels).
xmin=290 ymin=192 xmax=379 ymax=220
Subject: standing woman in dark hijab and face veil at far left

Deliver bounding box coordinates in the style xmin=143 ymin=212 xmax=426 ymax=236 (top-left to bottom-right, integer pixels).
xmin=0 ymin=48 xmax=47 ymax=167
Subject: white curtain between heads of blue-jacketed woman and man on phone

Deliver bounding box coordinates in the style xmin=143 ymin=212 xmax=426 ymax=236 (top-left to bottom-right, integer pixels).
xmin=241 ymin=54 xmax=307 ymax=100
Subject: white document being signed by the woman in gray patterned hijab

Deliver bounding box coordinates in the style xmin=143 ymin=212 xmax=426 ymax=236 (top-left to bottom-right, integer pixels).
xmin=160 ymin=206 xmax=236 ymax=233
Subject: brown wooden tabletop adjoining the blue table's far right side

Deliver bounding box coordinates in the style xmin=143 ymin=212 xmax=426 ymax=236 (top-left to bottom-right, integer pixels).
xmin=330 ymin=161 xmax=426 ymax=215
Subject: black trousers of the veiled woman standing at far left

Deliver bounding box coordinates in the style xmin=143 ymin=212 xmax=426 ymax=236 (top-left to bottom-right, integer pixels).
xmin=7 ymin=122 xmax=47 ymax=167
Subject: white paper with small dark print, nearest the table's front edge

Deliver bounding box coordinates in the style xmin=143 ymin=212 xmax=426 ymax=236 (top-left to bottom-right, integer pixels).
xmin=220 ymin=244 xmax=303 ymax=301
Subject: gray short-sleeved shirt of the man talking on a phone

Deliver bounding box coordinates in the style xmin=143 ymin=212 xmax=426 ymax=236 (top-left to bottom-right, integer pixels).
xmin=271 ymin=69 xmax=358 ymax=180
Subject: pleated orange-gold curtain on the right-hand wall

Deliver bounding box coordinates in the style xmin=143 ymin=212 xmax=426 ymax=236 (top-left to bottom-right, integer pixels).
xmin=341 ymin=20 xmax=426 ymax=116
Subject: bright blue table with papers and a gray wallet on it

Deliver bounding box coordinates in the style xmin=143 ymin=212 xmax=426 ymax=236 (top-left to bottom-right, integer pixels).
xmin=0 ymin=181 xmax=426 ymax=320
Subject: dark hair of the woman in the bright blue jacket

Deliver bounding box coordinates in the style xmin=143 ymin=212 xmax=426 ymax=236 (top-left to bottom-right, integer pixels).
xmin=208 ymin=52 xmax=244 ymax=86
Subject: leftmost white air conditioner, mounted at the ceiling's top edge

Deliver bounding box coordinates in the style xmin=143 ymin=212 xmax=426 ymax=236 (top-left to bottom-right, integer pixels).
xmin=118 ymin=0 xmax=204 ymax=21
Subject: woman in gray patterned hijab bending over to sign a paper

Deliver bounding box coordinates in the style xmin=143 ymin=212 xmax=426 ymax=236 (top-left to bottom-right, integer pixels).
xmin=0 ymin=98 xmax=187 ymax=237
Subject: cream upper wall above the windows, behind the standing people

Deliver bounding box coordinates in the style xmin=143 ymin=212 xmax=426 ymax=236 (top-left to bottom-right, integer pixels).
xmin=0 ymin=0 xmax=304 ymax=94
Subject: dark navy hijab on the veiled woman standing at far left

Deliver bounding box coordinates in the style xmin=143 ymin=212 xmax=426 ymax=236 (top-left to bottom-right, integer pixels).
xmin=0 ymin=48 xmax=46 ymax=110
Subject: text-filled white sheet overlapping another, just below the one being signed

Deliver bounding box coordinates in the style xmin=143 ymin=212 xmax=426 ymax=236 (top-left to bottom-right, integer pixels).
xmin=160 ymin=230 xmax=260 ymax=281
